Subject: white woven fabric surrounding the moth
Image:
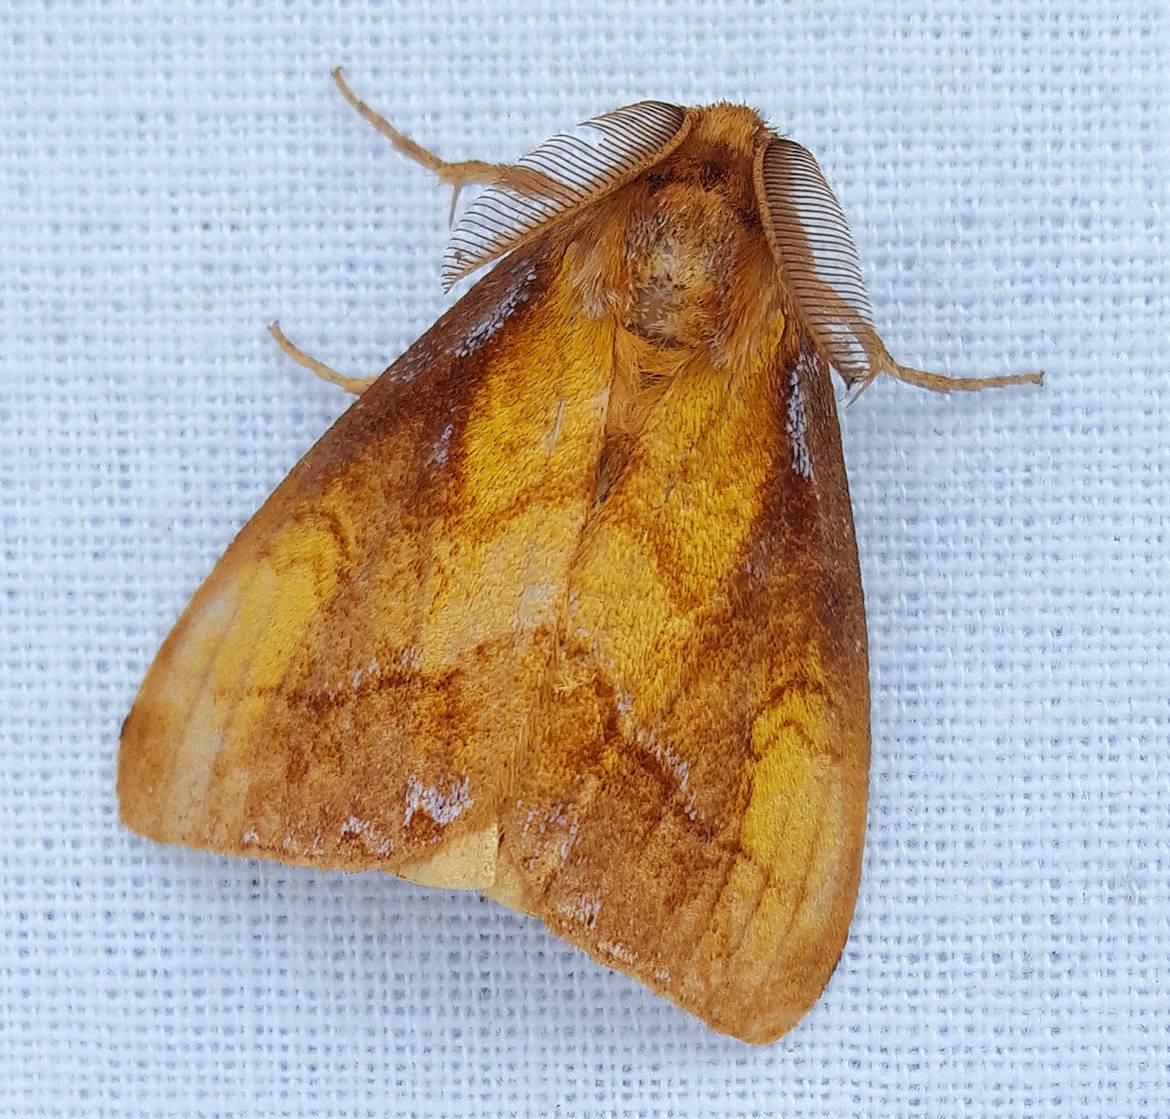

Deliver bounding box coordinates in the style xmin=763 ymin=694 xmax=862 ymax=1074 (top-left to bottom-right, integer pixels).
xmin=0 ymin=0 xmax=1170 ymax=1119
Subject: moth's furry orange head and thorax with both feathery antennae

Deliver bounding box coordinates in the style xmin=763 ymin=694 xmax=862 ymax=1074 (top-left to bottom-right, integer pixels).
xmin=443 ymin=101 xmax=889 ymax=386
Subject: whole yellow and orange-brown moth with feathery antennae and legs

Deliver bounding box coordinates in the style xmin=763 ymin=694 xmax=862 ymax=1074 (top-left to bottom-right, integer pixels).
xmin=118 ymin=75 xmax=1038 ymax=1043
